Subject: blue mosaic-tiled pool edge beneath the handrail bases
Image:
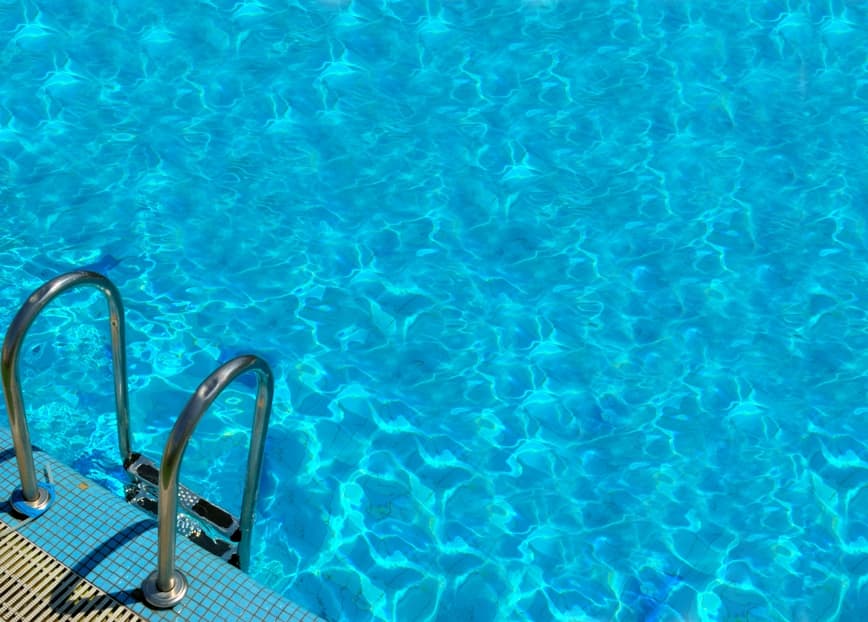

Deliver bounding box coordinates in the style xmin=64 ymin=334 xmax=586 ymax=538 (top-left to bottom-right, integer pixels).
xmin=0 ymin=428 xmax=321 ymax=622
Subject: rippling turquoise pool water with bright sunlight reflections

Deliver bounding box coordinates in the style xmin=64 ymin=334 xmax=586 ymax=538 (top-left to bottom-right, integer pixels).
xmin=0 ymin=0 xmax=868 ymax=621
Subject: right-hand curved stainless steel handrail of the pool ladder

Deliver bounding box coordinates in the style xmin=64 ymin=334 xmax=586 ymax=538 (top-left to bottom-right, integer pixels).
xmin=142 ymin=354 xmax=274 ymax=609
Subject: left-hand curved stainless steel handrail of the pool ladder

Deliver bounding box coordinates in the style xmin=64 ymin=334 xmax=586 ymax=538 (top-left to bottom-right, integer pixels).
xmin=0 ymin=270 xmax=131 ymax=516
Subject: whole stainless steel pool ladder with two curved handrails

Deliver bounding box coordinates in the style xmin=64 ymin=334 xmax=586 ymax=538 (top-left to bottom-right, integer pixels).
xmin=0 ymin=270 xmax=274 ymax=609
